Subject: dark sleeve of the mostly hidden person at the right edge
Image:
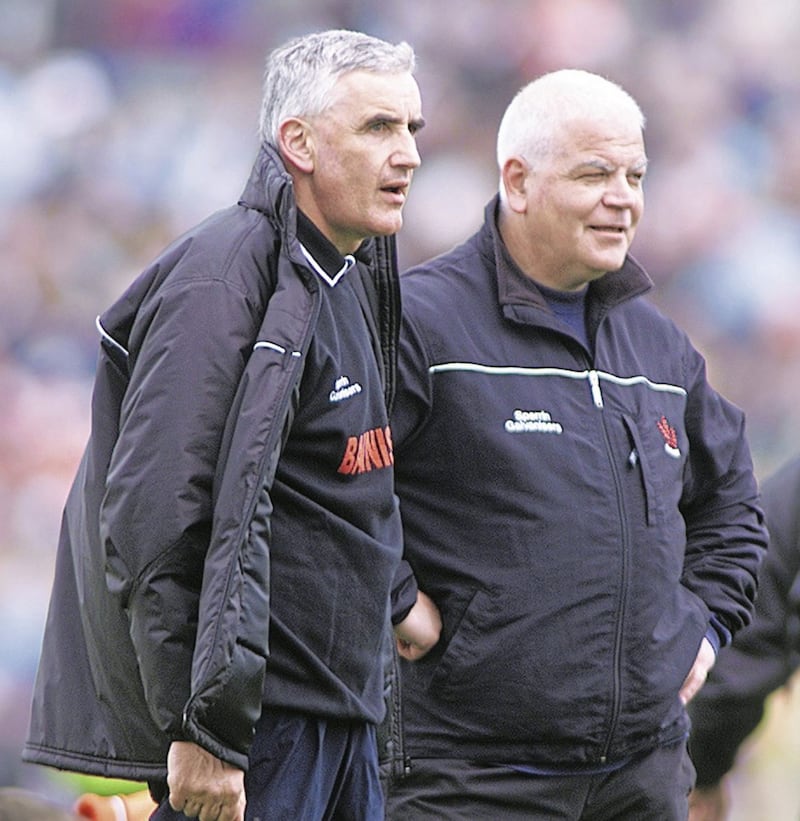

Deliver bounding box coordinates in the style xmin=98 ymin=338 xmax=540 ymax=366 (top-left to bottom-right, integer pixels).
xmin=689 ymin=458 xmax=800 ymax=787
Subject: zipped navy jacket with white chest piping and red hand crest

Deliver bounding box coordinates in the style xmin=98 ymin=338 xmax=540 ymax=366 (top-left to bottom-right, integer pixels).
xmin=392 ymin=202 xmax=766 ymax=771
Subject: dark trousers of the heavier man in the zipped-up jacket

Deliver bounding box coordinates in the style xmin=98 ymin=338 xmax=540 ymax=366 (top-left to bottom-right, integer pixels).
xmin=387 ymin=742 xmax=695 ymax=821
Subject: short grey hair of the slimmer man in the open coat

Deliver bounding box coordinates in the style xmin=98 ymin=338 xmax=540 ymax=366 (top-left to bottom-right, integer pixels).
xmin=259 ymin=29 xmax=416 ymax=146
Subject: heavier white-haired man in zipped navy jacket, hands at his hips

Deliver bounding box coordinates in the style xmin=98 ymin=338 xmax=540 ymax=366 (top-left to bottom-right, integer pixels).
xmin=388 ymin=69 xmax=767 ymax=821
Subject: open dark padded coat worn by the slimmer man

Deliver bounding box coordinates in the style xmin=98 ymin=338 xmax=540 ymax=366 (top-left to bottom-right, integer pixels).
xmin=24 ymin=148 xmax=399 ymax=779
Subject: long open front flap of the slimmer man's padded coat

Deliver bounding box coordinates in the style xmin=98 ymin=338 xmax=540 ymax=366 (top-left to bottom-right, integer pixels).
xmin=182 ymin=259 xmax=319 ymax=769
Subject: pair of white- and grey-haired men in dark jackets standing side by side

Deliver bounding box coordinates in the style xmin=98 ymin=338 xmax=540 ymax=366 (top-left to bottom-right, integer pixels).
xmin=26 ymin=27 xmax=766 ymax=821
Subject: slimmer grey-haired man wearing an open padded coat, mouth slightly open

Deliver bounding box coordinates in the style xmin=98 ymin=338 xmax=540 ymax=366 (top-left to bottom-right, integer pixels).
xmin=24 ymin=31 xmax=423 ymax=821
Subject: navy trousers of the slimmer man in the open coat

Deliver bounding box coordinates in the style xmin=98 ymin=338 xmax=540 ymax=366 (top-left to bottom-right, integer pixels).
xmin=151 ymin=713 xmax=384 ymax=821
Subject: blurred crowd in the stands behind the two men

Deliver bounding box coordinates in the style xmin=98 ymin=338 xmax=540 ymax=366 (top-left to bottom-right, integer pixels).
xmin=0 ymin=0 xmax=800 ymax=821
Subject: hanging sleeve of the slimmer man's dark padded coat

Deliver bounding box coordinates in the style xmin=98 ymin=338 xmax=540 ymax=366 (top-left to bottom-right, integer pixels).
xmin=100 ymin=276 xmax=257 ymax=738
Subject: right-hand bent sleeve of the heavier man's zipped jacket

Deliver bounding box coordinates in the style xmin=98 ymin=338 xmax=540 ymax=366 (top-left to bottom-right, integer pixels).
xmin=681 ymin=342 xmax=767 ymax=646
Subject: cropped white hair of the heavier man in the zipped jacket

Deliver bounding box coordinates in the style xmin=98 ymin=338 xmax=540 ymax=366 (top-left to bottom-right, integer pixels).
xmin=497 ymin=68 xmax=645 ymax=173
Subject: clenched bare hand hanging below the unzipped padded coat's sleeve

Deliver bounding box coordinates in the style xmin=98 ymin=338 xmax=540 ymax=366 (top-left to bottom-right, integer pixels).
xmin=167 ymin=741 xmax=245 ymax=821
